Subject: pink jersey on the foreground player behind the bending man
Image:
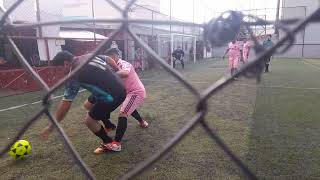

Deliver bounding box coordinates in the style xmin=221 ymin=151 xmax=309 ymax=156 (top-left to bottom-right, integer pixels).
xmin=117 ymin=59 xmax=146 ymax=98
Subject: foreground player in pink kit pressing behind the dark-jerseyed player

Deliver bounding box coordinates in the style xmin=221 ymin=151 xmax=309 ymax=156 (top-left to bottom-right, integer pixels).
xmin=84 ymin=48 xmax=148 ymax=154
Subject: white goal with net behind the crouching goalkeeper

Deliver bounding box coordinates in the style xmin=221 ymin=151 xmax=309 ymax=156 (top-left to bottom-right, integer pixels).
xmin=158 ymin=33 xmax=197 ymax=67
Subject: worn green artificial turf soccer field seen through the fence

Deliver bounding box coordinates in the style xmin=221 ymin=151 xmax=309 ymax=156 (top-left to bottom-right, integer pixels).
xmin=0 ymin=59 xmax=320 ymax=179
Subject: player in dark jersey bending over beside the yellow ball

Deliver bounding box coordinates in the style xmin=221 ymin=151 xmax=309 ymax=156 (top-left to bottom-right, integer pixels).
xmin=40 ymin=51 xmax=126 ymax=154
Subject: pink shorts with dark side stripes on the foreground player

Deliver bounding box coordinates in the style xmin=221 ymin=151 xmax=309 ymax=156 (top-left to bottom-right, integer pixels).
xmin=120 ymin=94 xmax=144 ymax=116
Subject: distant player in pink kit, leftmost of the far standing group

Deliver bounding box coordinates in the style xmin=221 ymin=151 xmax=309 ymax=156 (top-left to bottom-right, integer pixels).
xmin=223 ymin=40 xmax=240 ymax=76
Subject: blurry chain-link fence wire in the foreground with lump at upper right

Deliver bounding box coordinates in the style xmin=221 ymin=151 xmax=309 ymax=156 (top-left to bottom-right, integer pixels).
xmin=0 ymin=0 xmax=320 ymax=179
